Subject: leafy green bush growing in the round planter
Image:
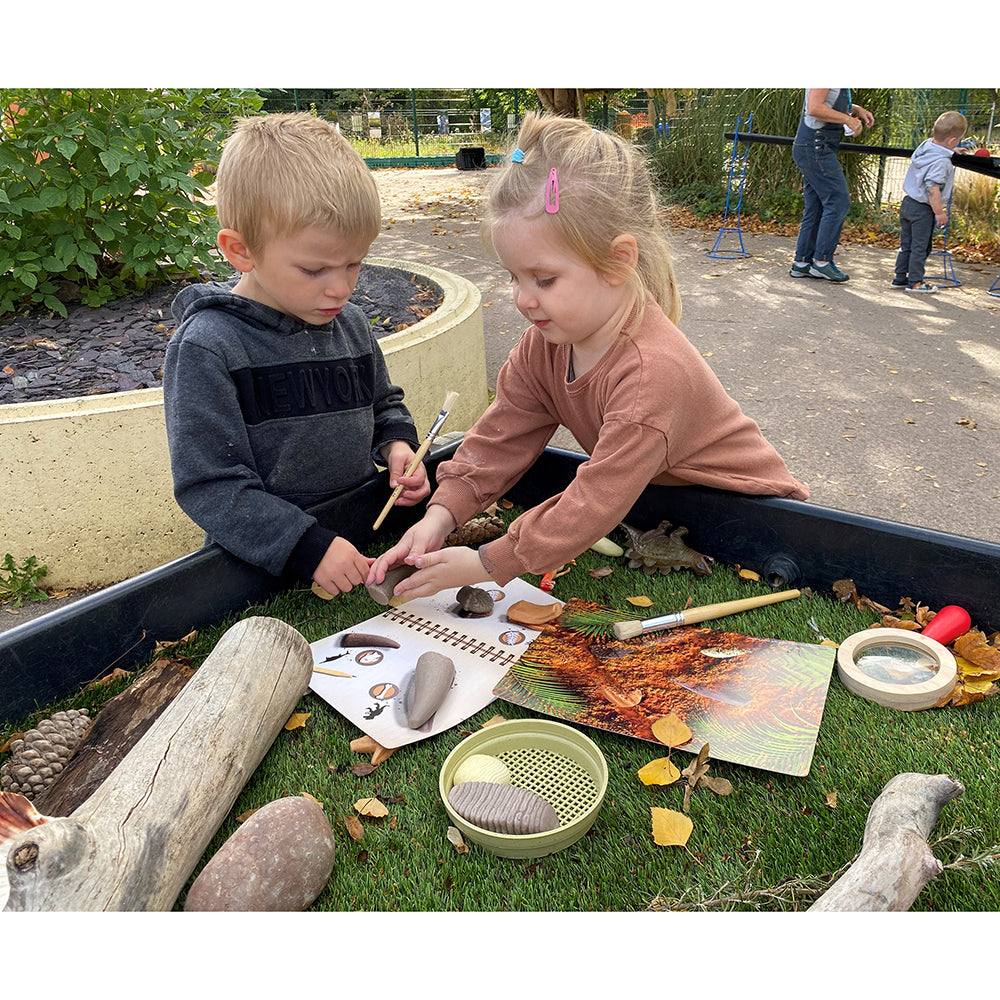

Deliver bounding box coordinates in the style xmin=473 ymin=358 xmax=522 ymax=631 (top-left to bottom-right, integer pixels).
xmin=0 ymin=90 xmax=261 ymax=316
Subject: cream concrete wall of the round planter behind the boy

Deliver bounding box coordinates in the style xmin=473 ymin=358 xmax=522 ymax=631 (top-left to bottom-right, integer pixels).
xmin=0 ymin=258 xmax=488 ymax=588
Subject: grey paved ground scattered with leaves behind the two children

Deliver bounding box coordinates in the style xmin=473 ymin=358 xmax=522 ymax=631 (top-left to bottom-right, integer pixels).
xmin=373 ymin=168 xmax=1000 ymax=542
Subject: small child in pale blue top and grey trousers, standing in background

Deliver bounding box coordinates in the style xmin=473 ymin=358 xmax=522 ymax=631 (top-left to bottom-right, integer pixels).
xmin=892 ymin=111 xmax=968 ymax=293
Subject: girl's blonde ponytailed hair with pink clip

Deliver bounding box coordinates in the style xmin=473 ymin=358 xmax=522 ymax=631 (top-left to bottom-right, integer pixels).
xmin=483 ymin=113 xmax=681 ymax=323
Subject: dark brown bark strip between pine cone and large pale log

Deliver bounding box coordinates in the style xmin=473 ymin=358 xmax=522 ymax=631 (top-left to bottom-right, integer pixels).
xmin=34 ymin=660 xmax=194 ymax=816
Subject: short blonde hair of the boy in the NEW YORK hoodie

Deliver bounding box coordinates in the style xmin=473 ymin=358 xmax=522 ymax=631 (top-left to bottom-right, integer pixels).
xmin=215 ymin=112 xmax=382 ymax=253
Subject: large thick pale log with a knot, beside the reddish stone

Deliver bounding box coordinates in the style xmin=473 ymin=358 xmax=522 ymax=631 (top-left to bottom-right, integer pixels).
xmin=6 ymin=618 xmax=312 ymax=911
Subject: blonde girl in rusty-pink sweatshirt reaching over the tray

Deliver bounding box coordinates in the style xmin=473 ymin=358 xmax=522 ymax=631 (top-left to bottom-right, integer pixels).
xmin=367 ymin=115 xmax=808 ymax=598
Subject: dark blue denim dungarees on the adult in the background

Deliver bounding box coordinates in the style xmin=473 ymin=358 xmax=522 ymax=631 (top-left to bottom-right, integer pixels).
xmin=792 ymin=125 xmax=851 ymax=262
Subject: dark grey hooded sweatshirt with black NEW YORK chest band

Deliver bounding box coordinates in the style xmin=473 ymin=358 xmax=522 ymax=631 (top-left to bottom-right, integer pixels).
xmin=163 ymin=279 xmax=417 ymax=579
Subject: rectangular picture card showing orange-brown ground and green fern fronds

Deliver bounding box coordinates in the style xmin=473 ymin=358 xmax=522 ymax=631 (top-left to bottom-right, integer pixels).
xmin=493 ymin=598 xmax=836 ymax=776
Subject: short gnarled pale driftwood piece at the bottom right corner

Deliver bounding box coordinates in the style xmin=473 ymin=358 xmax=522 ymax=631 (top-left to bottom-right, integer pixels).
xmin=809 ymin=774 xmax=965 ymax=913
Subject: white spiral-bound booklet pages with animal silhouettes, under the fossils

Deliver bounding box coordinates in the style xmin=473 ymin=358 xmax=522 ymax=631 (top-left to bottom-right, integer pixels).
xmin=309 ymin=579 xmax=556 ymax=749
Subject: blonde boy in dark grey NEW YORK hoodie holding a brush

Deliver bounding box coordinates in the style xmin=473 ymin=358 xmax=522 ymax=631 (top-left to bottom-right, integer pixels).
xmin=163 ymin=113 xmax=430 ymax=595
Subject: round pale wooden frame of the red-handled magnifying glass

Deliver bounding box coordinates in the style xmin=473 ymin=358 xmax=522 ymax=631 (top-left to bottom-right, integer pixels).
xmin=837 ymin=628 xmax=958 ymax=712
